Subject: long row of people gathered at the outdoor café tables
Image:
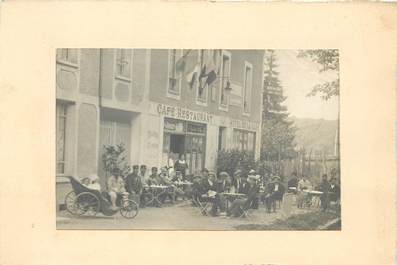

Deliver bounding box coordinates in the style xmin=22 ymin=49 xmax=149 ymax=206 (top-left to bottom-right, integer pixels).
xmin=78 ymin=162 xmax=340 ymax=217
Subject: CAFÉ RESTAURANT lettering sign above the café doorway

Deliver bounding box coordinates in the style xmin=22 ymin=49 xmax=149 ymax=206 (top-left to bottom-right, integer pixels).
xmin=157 ymin=104 xmax=212 ymax=123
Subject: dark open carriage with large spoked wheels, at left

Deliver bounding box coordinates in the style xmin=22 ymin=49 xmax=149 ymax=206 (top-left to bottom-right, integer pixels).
xmin=65 ymin=177 xmax=139 ymax=219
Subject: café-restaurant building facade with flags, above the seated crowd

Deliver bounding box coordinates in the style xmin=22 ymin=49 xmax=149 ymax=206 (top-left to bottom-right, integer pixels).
xmin=56 ymin=49 xmax=263 ymax=208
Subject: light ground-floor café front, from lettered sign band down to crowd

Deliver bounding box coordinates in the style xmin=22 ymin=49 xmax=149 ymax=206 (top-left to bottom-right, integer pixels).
xmin=149 ymin=102 xmax=260 ymax=174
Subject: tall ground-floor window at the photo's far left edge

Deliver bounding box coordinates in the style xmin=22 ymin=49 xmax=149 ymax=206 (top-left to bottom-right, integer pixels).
xmin=56 ymin=104 xmax=67 ymax=175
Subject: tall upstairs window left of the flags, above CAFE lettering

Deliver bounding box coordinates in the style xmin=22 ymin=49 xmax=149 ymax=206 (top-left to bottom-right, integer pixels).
xmin=167 ymin=49 xmax=183 ymax=96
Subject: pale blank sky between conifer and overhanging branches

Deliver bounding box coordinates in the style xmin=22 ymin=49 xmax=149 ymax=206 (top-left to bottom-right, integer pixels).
xmin=276 ymin=50 xmax=339 ymax=120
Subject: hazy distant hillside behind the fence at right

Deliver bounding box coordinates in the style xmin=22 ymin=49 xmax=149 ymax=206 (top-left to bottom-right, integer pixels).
xmin=291 ymin=117 xmax=338 ymax=155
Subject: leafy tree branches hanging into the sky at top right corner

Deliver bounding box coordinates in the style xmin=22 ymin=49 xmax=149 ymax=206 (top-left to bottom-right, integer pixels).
xmin=298 ymin=50 xmax=339 ymax=100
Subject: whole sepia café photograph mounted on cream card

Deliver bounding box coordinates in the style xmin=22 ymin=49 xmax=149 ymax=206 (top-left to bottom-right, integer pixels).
xmin=55 ymin=48 xmax=342 ymax=231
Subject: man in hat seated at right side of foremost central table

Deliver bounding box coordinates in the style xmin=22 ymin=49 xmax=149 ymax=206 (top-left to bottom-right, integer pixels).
xmin=227 ymin=173 xmax=259 ymax=217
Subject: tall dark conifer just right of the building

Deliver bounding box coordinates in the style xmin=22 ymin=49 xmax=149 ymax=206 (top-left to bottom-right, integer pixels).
xmin=261 ymin=50 xmax=295 ymax=161
